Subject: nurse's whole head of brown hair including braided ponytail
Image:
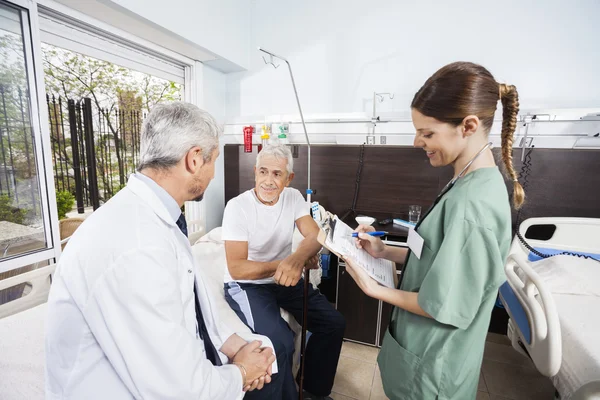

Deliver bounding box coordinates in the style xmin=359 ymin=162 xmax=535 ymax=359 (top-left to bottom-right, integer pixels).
xmin=411 ymin=62 xmax=525 ymax=209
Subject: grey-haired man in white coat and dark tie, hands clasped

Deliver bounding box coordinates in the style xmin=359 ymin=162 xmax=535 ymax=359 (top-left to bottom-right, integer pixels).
xmin=46 ymin=102 xmax=275 ymax=400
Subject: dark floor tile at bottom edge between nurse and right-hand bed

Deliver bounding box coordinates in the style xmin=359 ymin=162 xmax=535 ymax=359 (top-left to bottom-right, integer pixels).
xmin=482 ymin=359 xmax=554 ymax=400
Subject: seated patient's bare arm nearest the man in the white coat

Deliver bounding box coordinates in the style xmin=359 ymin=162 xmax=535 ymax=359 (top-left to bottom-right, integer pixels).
xmin=225 ymin=240 xmax=280 ymax=280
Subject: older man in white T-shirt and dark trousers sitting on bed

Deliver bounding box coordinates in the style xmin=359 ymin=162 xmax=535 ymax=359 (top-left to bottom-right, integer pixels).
xmin=223 ymin=145 xmax=345 ymax=400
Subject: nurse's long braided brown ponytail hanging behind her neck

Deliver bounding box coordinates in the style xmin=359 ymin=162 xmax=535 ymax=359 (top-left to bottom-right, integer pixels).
xmin=498 ymin=83 xmax=525 ymax=209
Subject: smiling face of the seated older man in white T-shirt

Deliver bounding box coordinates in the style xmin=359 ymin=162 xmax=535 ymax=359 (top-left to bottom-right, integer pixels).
xmin=254 ymin=156 xmax=294 ymax=205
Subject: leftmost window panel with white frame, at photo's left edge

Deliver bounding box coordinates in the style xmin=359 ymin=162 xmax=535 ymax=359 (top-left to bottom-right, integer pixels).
xmin=0 ymin=1 xmax=55 ymax=272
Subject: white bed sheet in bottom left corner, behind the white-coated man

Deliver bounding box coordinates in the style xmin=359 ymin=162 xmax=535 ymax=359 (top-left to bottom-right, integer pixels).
xmin=0 ymin=303 xmax=46 ymax=400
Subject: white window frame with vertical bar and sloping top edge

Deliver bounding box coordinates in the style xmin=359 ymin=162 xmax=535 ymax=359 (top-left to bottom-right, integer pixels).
xmin=0 ymin=0 xmax=205 ymax=273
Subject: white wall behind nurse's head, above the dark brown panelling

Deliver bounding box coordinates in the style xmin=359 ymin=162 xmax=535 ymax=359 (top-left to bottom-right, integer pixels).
xmin=227 ymin=0 xmax=600 ymax=119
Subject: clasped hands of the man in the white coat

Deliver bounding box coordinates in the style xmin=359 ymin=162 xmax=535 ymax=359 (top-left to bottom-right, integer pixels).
xmin=233 ymin=340 xmax=275 ymax=391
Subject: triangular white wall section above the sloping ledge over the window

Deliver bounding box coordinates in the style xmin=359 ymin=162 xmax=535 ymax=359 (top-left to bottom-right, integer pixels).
xmin=102 ymin=0 xmax=250 ymax=68
